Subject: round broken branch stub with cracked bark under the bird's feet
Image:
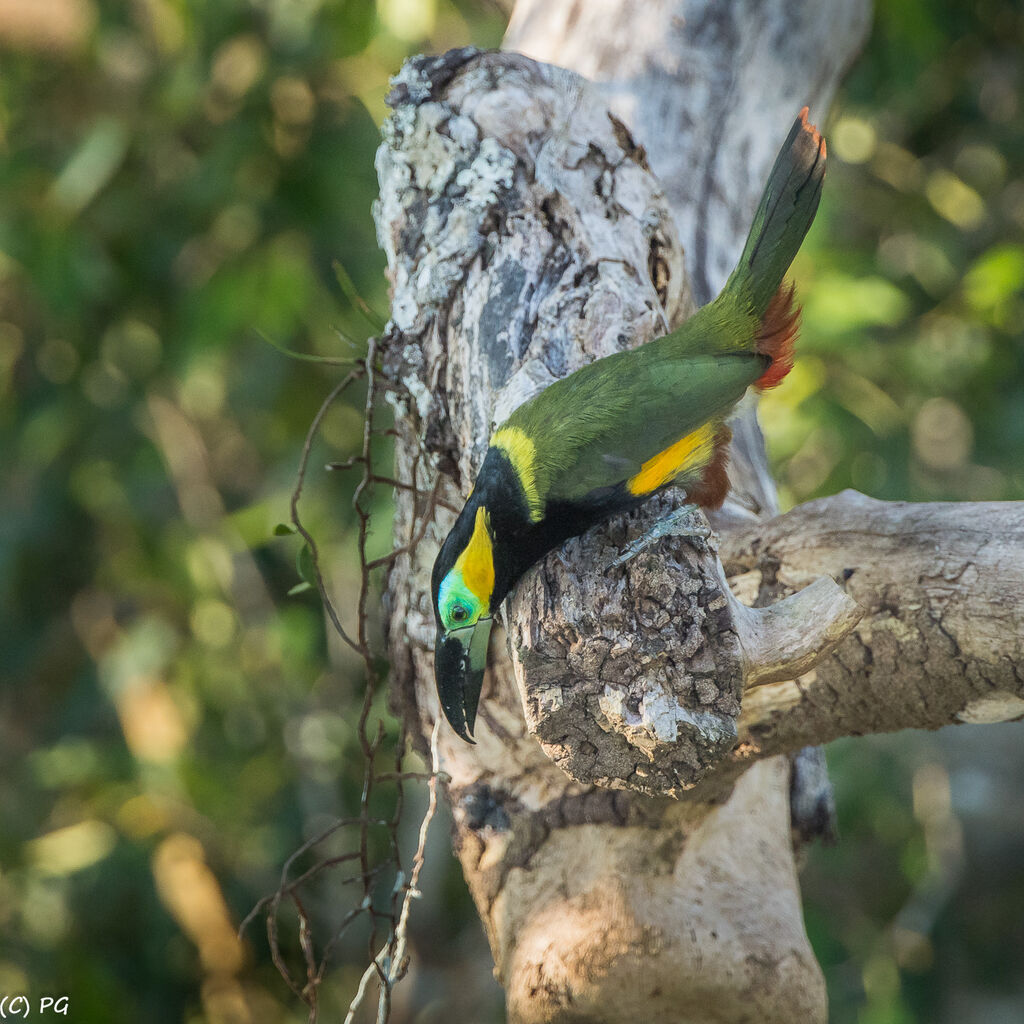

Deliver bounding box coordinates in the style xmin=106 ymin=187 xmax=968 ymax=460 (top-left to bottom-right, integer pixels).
xmin=506 ymin=494 xmax=743 ymax=797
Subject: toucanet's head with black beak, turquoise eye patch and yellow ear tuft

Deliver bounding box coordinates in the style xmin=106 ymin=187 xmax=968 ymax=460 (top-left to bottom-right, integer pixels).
xmin=431 ymin=499 xmax=496 ymax=742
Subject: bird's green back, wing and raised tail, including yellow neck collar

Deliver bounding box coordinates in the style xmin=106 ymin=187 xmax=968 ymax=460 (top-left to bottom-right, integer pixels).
xmin=492 ymin=106 xmax=825 ymax=507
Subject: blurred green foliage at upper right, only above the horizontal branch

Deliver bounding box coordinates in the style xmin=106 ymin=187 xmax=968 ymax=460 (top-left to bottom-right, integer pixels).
xmin=763 ymin=0 xmax=1024 ymax=512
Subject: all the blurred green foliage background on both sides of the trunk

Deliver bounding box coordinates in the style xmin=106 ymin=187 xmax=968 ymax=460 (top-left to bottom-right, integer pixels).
xmin=0 ymin=0 xmax=1024 ymax=1024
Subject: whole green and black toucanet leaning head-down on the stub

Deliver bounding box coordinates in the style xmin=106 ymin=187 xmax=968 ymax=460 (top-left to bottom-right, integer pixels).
xmin=431 ymin=106 xmax=825 ymax=742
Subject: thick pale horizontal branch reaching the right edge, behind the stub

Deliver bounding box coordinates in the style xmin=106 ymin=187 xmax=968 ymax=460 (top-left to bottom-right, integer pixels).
xmin=723 ymin=490 xmax=1024 ymax=758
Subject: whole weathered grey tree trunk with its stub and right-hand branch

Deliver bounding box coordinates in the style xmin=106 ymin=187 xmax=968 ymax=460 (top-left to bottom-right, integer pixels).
xmin=376 ymin=0 xmax=1007 ymax=1024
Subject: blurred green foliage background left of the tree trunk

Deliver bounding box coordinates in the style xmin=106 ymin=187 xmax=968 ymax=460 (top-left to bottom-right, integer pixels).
xmin=0 ymin=0 xmax=501 ymax=1024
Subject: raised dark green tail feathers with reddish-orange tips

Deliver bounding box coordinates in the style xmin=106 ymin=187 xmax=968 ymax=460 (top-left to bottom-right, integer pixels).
xmin=726 ymin=106 xmax=825 ymax=319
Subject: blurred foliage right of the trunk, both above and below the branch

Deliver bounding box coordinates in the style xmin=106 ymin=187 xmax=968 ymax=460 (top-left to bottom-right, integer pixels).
xmin=763 ymin=0 xmax=1024 ymax=1024
